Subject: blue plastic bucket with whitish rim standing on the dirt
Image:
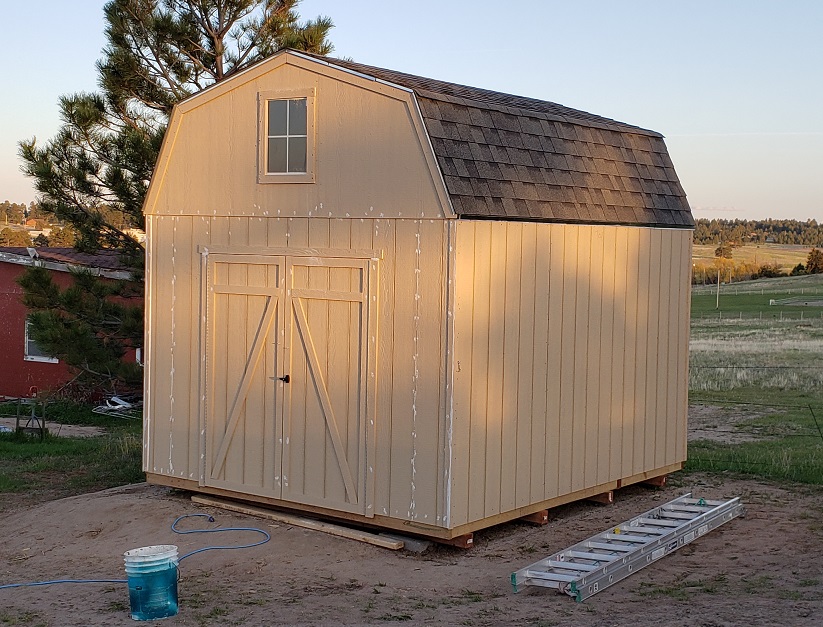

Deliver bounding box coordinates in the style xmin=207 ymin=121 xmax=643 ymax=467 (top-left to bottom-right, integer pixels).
xmin=123 ymin=544 xmax=177 ymax=620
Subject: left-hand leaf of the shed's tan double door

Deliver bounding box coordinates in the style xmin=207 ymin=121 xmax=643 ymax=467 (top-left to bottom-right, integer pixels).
xmin=203 ymin=254 xmax=286 ymax=498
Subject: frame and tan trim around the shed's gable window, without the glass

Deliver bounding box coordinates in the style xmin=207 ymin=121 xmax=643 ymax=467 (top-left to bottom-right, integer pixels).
xmin=257 ymin=87 xmax=316 ymax=183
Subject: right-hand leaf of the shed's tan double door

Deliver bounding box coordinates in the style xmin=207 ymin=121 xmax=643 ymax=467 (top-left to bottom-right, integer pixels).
xmin=283 ymin=257 xmax=373 ymax=513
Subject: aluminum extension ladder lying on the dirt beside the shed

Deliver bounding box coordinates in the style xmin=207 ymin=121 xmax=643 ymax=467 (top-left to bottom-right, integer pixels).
xmin=511 ymin=493 xmax=743 ymax=601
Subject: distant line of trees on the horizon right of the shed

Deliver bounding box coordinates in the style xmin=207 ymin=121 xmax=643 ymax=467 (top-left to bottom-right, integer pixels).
xmin=694 ymin=218 xmax=823 ymax=246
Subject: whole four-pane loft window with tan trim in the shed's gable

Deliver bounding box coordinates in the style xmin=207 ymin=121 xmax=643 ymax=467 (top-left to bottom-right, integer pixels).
xmin=258 ymin=89 xmax=314 ymax=183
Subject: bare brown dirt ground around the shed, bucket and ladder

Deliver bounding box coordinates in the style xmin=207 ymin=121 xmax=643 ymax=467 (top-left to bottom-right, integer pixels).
xmin=0 ymin=474 xmax=823 ymax=627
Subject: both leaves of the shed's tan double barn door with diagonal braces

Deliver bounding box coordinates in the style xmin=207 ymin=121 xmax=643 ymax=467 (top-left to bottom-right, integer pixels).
xmin=201 ymin=252 xmax=374 ymax=515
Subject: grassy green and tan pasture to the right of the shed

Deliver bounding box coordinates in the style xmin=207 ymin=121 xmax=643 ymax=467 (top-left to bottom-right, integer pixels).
xmin=687 ymin=277 xmax=823 ymax=484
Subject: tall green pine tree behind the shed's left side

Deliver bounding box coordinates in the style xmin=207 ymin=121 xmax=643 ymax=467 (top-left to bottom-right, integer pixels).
xmin=20 ymin=0 xmax=332 ymax=389
